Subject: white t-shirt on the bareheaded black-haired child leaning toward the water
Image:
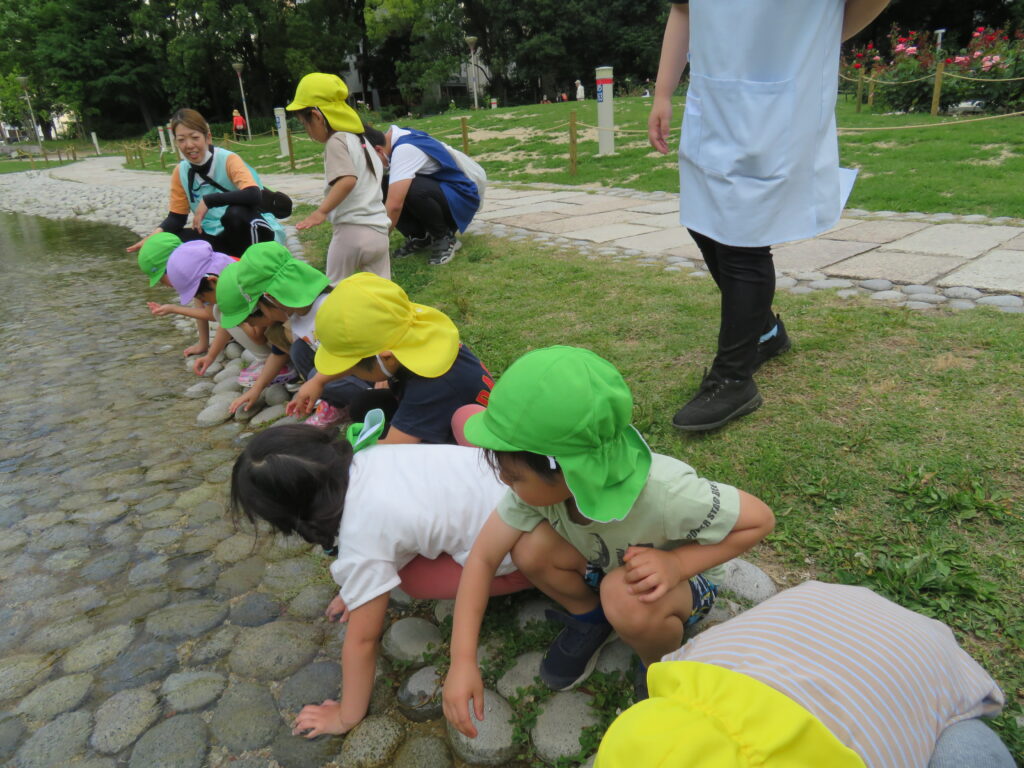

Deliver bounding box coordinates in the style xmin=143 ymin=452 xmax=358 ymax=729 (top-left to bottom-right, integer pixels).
xmin=331 ymin=444 xmax=515 ymax=610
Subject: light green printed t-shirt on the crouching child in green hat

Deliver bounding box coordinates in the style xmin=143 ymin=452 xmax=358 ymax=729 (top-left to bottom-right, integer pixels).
xmin=498 ymin=454 xmax=739 ymax=584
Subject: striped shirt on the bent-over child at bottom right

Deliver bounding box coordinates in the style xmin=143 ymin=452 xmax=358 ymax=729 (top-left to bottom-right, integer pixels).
xmin=663 ymin=582 xmax=1004 ymax=768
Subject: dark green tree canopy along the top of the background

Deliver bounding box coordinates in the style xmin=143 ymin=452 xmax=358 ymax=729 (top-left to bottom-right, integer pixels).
xmin=0 ymin=0 xmax=1024 ymax=137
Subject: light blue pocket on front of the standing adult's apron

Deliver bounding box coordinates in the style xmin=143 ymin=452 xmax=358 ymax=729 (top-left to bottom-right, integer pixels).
xmin=687 ymin=75 xmax=799 ymax=178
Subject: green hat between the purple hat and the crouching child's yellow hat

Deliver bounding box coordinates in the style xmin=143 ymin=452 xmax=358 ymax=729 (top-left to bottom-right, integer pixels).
xmin=217 ymin=242 xmax=329 ymax=328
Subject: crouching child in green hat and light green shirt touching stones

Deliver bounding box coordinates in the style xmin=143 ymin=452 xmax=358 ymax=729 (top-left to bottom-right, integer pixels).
xmin=444 ymin=347 xmax=774 ymax=737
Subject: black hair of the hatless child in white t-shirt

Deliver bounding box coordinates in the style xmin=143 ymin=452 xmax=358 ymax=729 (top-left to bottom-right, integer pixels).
xmin=228 ymin=424 xmax=352 ymax=550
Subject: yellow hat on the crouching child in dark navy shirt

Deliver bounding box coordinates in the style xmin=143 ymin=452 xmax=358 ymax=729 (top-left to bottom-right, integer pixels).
xmin=315 ymin=272 xmax=459 ymax=379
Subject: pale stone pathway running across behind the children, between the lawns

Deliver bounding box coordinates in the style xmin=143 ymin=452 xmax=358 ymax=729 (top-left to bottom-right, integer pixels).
xmin=0 ymin=158 xmax=1024 ymax=312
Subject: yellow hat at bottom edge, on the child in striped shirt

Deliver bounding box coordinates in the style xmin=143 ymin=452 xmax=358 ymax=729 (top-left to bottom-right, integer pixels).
xmin=594 ymin=662 xmax=864 ymax=768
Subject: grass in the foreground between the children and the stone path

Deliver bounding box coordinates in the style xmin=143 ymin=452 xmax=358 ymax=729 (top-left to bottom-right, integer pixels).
xmin=304 ymin=211 xmax=1024 ymax=756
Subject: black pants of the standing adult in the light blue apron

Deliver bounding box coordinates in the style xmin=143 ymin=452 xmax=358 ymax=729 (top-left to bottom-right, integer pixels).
xmin=689 ymin=229 xmax=775 ymax=379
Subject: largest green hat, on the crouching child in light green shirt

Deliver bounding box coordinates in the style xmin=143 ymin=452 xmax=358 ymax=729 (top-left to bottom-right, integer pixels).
xmin=466 ymin=346 xmax=650 ymax=522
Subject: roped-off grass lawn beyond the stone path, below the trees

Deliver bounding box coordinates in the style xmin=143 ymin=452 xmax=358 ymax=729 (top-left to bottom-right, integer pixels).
xmin=121 ymin=96 xmax=1024 ymax=217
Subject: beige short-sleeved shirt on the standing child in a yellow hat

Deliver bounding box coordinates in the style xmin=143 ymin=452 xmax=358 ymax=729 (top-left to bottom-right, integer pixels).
xmin=324 ymin=131 xmax=390 ymax=234
